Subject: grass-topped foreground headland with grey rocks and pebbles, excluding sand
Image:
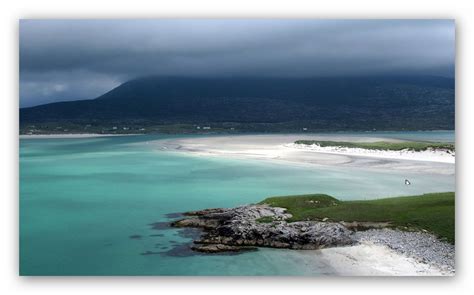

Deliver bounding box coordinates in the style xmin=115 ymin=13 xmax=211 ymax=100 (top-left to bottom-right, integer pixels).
xmin=172 ymin=192 xmax=455 ymax=274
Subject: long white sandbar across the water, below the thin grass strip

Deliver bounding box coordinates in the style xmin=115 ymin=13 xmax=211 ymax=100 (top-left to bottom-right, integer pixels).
xmin=154 ymin=134 xmax=455 ymax=175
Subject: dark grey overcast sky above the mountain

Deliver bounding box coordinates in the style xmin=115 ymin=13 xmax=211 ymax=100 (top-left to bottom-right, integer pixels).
xmin=20 ymin=19 xmax=455 ymax=107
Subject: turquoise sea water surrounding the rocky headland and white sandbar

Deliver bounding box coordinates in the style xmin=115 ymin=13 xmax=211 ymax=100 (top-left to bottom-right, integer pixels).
xmin=19 ymin=131 xmax=455 ymax=275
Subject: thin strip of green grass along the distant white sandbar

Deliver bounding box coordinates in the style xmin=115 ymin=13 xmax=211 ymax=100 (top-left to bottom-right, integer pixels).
xmin=295 ymin=140 xmax=454 ymax=151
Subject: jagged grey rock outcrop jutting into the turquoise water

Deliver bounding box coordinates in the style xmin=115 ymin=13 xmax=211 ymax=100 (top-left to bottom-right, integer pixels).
xmin=172 ymin=205 xmax=356 ymax=253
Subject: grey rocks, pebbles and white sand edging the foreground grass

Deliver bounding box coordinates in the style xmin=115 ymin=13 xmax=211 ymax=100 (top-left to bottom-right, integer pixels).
xmin=171 ymin=205 xmax=455 ymax=276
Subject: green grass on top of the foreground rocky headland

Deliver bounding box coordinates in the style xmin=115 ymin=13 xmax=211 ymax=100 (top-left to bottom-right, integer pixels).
xmin=261 ymin=192 xmax=455 ymax=244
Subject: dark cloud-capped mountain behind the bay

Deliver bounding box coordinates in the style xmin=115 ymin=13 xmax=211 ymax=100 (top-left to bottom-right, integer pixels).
xmin=20 ymin=77 xmax=454 ymax=130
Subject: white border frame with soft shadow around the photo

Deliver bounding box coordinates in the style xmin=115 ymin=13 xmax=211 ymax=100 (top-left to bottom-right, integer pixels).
xmin=0 ymin=0 xmax=474 ymax=295
